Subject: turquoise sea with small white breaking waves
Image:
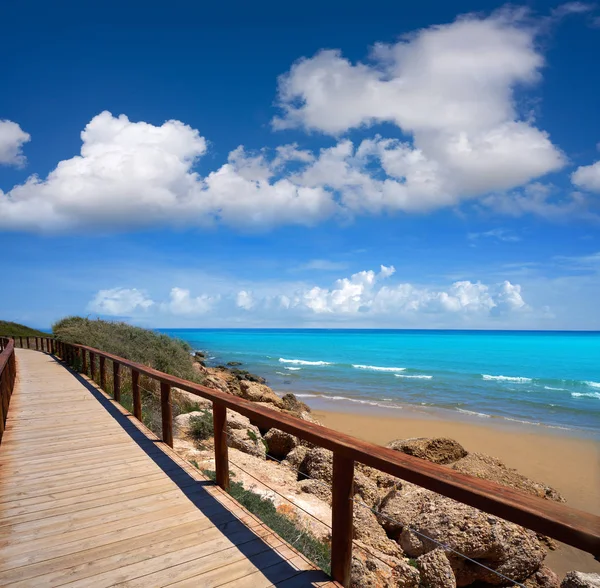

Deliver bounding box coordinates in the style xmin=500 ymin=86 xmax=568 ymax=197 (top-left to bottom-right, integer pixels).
xmin=160 ymin=329 xmax=600 ymax=437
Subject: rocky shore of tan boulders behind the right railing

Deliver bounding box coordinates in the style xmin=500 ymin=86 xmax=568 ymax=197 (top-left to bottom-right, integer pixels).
xmin=170 ymin=354 xmax=600 ymax=588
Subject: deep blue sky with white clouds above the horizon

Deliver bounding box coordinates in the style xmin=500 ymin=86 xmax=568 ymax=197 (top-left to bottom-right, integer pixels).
xmin=0 ymin=0 xmax=600 ymax=330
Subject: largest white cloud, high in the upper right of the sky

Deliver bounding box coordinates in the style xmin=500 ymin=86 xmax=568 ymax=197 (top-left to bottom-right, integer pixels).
xmin=274 ymin=11 xmax=565 ymax=210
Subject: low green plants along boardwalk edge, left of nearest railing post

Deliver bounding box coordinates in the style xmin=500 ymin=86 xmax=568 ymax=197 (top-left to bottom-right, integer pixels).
xmin=203 ymin=470 xmax=331 ymax=573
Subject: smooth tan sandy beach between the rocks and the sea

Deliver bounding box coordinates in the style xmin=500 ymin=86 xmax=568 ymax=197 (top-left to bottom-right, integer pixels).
xmin=313 ymin=410 xmax=600 ymax=577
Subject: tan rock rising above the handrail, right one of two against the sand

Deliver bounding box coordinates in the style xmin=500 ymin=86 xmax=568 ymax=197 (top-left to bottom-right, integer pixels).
xmin=451 ymin=453 xmax=565 ymax=502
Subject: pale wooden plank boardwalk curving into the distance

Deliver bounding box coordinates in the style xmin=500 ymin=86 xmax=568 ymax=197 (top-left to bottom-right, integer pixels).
xmin=0 ymin=349 xmax=337 ymax=588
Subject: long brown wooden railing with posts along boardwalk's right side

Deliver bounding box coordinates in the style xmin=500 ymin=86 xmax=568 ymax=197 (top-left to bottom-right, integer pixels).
xmin=5 ymin=337 xmax=600 ymax=586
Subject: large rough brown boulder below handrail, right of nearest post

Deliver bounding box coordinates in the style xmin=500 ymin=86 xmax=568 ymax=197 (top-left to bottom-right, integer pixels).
xmin=379 ymin=483 xmax=545 ymax=586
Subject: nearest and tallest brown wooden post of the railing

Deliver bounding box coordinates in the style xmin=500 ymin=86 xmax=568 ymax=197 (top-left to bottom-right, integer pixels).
xmin=331 ymin=452 xmax=354 ymax=588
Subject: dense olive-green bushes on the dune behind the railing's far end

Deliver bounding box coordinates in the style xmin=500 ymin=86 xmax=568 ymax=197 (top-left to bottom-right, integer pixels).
xmin=52 ymin=316 xmax=204 ymax=436
